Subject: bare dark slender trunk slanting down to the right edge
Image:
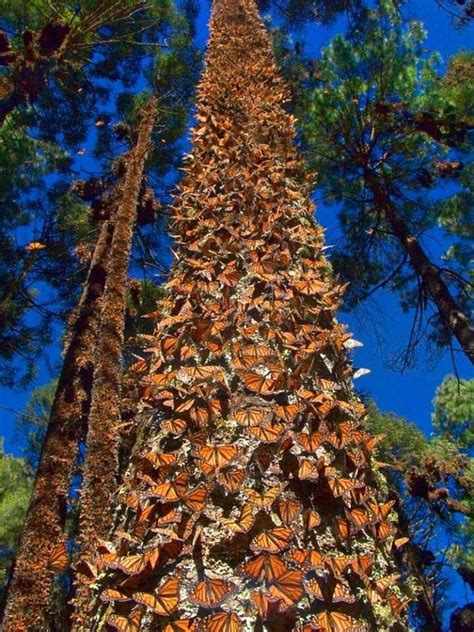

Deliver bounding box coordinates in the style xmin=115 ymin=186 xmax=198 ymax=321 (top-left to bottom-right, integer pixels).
xmin=365 ymin=171 xmax=474 ymax=363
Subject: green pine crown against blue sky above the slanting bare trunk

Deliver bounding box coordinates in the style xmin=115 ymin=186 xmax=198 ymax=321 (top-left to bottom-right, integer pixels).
xmin=298 ymin=0 xmax=474 ymax=359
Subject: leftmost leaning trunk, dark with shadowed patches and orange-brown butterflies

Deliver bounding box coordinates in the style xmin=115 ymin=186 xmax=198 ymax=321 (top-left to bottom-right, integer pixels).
xmin=3 ymin=221 xmax=113 ymax=632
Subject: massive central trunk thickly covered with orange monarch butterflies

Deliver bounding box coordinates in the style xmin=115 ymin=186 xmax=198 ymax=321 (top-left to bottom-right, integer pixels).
xmin=77 ymin=0 xmax=412 ymax=632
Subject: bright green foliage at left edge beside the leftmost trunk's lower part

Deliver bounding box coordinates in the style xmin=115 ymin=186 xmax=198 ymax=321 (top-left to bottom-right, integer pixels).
xmin=0 ymin=441 xmax=31 ymax=606
